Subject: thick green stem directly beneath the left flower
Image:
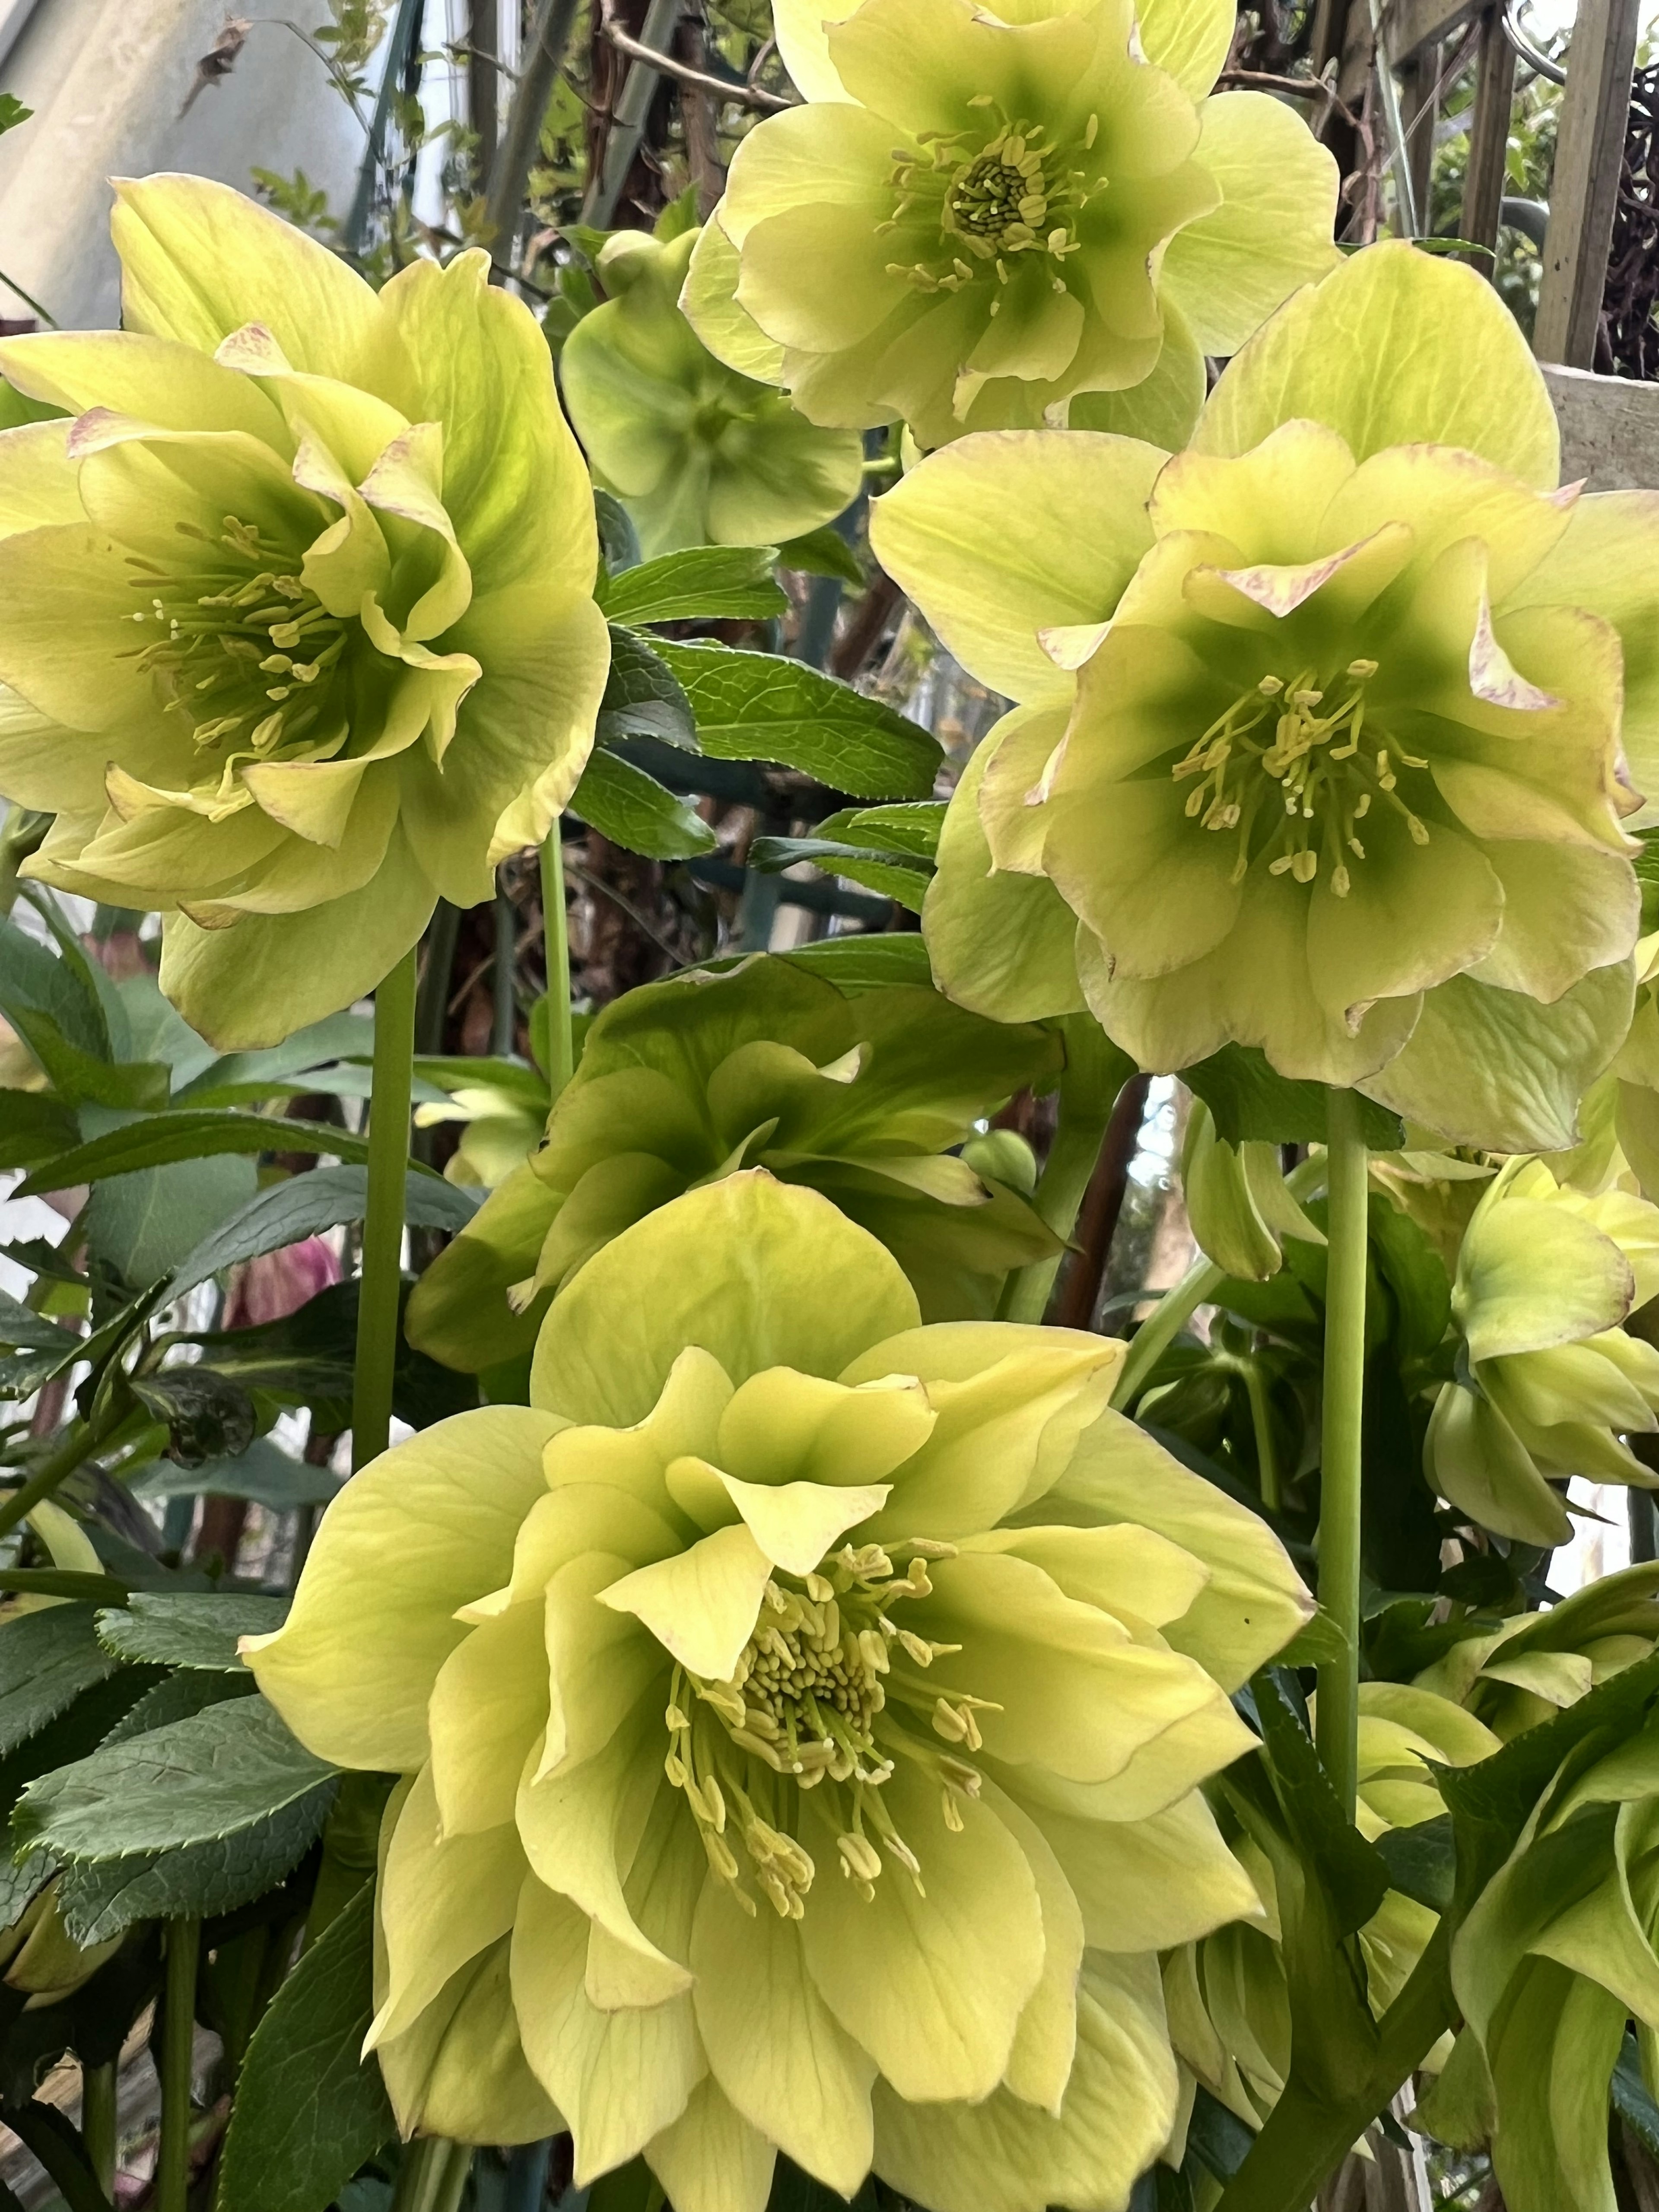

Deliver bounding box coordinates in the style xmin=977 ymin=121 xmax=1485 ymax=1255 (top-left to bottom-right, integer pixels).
xmin=352 ymin=951 xmax=416 ymax=1467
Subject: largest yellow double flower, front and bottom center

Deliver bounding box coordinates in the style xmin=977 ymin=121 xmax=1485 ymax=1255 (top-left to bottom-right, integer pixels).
xmin=243 ymin=1170 xmax=1309 ymax=2212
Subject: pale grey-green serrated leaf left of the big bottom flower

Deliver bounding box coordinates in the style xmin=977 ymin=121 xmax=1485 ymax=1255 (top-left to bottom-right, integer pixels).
xmin=11 ymin=1697 xmax=334 ymax=1865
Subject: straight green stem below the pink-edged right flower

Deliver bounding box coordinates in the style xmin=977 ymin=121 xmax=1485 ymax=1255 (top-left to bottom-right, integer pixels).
xmin=1319 ymin=1090 xmax=1367 ymax=1821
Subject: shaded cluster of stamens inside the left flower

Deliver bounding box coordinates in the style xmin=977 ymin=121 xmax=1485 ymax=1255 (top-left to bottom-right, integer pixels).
xmin=130 ymin=515 xmax=345 ymax=774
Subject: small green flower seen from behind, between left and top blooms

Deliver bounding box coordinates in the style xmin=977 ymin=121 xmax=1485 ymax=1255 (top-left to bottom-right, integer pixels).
xmin=559 ymin=230 xmax=865 ymax=559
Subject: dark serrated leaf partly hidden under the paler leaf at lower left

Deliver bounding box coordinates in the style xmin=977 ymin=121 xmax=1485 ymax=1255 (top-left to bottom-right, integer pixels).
xmin=57 ymin=1787 xmax=336 ymax=1944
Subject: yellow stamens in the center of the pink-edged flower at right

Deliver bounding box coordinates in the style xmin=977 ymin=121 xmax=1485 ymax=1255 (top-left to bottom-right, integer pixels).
xmin=1170 ymin=659 xmax=1429 ymax=898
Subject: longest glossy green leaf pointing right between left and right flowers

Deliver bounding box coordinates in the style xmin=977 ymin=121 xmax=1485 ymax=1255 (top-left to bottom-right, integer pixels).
xmin=657 ymin=639 xmax=942 ymax=798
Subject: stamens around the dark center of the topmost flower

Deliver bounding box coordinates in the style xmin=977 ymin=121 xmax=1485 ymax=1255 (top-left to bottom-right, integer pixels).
xmin=878 ymin=93 xmax=1100 ymax=314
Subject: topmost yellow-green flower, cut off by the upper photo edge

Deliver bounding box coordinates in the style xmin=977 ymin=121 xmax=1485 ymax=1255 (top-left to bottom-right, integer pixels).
xmin=686 ymin=0 xmax=1336 ymax=447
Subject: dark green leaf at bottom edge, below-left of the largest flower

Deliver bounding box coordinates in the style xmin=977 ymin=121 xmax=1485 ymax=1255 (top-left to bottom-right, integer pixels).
xmin=223 ymin=1887 xmax=396 ymax=2212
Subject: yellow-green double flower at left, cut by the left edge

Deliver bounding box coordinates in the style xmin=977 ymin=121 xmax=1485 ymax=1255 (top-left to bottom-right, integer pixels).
xmin=0 ymin=177 xmax=608 ymax=1046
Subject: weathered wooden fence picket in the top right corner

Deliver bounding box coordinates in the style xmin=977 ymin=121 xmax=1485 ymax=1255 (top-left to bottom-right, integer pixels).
xmin=1533 ymin=0 xmax=1639 ymax=369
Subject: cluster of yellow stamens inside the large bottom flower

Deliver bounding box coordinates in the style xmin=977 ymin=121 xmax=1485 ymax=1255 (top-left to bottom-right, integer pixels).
xmin=664 ymin=1537 xmax=993 ymax=1920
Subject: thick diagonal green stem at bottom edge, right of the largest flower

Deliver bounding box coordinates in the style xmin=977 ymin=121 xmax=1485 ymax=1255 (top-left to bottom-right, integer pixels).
xmin=1217 ymin=1916 xmax=1456 ymax=2212
